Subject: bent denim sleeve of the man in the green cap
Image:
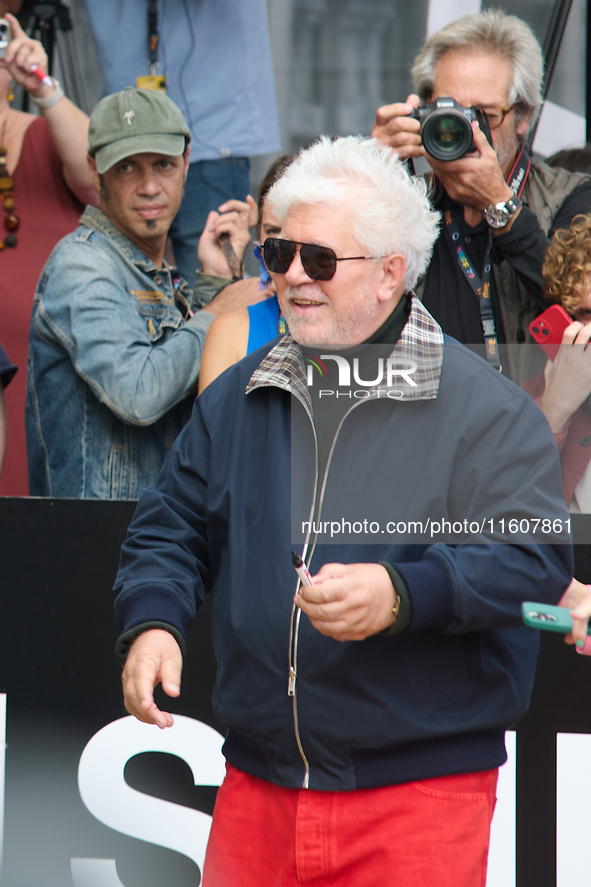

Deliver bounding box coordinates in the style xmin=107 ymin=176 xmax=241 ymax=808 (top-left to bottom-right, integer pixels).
xmin=35 ymin=240 xmax=214 ymax=425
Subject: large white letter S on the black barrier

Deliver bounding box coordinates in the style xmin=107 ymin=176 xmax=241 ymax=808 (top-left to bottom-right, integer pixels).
xmin=71 ymin=715 xmax=225 ymax=887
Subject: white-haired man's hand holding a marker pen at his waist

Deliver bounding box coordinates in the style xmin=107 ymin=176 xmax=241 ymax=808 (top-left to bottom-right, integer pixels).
xmin=295 ymin=564 xmax=397 ymax=641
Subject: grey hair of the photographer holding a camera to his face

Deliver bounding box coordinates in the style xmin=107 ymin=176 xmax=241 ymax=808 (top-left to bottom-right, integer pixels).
xmin=412 ymin=9 xmax=544 ymax=132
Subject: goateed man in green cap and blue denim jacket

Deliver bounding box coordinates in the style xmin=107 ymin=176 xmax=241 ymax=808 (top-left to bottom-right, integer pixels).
xmin=26 ymin=87 xmax=256 ymax=499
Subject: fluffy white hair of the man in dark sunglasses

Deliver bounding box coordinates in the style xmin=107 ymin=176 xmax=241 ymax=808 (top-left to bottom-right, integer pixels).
xmin=267 ymin=136 xmax=440 ymax=289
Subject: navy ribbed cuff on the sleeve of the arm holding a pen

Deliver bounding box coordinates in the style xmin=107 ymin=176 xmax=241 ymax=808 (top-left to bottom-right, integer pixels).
xmin=396 ymin=557 xmax=454 ymax=631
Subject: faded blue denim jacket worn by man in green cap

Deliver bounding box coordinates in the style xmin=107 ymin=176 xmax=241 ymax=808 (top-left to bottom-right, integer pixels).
xmin=26 ymin=207 xmax=213 ymax=499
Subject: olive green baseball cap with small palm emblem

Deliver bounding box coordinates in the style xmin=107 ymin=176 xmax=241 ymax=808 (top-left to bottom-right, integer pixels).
xmin=88 ymin=86 xmax=191 ymax=173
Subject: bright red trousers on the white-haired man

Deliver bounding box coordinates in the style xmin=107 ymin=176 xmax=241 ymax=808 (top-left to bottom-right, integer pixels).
xmin=203 ymin=764 xmax=497 ymax=887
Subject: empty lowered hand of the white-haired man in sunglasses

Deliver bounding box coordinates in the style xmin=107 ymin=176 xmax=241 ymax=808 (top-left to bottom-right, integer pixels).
xmin=121 ymin=628 xmax=183 ymax=730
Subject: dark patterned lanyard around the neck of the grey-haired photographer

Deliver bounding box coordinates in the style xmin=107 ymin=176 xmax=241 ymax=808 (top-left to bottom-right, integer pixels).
xmin=443 ymin=146 xmax=531 ymax=372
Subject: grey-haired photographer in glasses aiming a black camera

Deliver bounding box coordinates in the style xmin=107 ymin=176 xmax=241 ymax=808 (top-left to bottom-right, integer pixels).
xmin=373 ymin=10 xmax=591 ymax=383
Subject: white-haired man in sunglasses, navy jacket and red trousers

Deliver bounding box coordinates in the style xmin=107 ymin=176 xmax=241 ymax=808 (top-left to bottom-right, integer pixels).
xmin=116 ymin=137 xmax=571 ymax=887
